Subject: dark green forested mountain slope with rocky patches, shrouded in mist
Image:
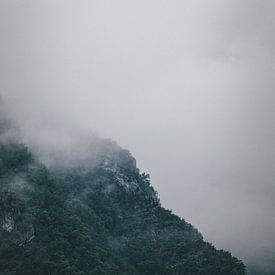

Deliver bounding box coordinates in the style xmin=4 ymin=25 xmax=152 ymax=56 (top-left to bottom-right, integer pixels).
xmin=0 ymin=140 xmax=245 ymax=275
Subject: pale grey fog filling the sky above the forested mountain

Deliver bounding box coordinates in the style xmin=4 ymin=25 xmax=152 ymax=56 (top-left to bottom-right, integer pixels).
xmin=0 ymin=0 xmax=275 ymax=274
